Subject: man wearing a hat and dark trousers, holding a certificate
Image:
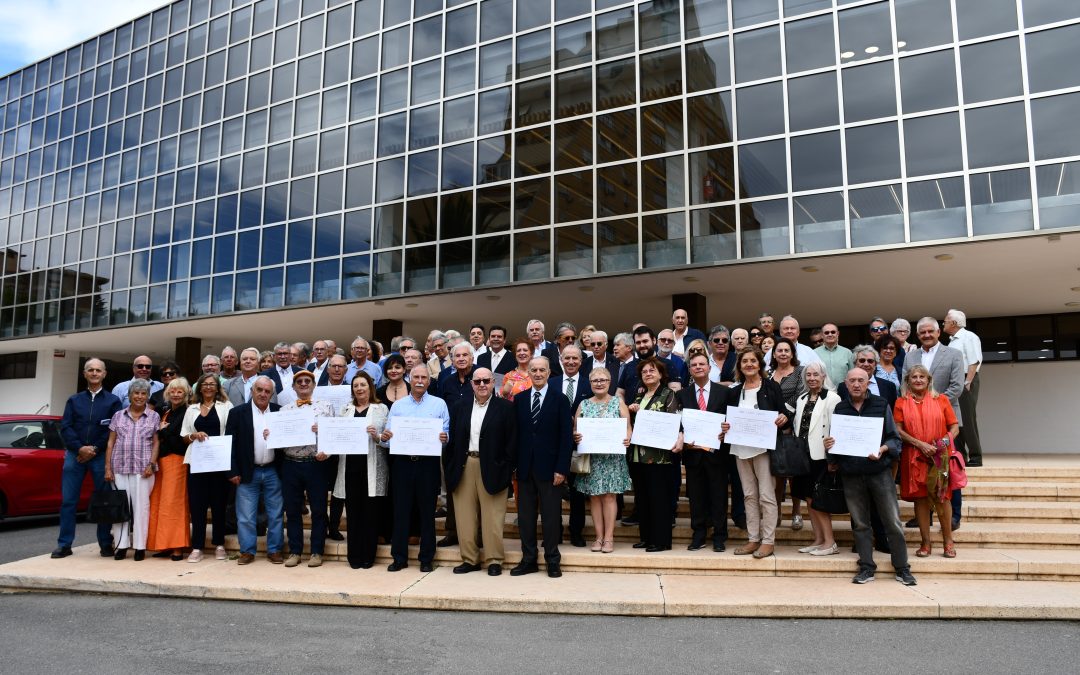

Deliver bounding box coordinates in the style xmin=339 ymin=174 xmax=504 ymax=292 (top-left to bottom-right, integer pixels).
xmin=274 ymin=370 xmax=334 ymax=567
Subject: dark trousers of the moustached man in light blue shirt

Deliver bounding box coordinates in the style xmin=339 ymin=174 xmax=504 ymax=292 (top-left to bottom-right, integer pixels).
xmin=390 ymin=455 xmax=442 ymax=565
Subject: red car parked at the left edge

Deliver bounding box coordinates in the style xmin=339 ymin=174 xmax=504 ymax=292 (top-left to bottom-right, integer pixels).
xmin=0 ymin=415 xmax=94 ymax=518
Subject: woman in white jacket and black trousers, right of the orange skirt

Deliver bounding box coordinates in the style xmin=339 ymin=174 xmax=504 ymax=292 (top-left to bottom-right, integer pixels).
xmin=180 ymin=374 xmax=232 ymax=563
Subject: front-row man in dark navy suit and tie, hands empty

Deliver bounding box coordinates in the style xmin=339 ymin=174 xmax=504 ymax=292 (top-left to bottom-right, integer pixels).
xmin=510 ymin=356 xmax=573 ymax=578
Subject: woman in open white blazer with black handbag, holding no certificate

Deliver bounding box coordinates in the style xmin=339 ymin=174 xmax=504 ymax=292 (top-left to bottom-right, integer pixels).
xmin=792 ymin=362 xmax=840 ymax=555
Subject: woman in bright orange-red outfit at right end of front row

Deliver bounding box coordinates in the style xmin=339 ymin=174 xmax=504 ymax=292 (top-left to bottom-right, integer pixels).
xmin=893 ymin=365 xmax=960 ymax=557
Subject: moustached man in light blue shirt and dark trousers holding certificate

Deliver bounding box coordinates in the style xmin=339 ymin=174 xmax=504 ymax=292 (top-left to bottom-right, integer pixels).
xmin=381 ymin=365 xmax=450 ymax=572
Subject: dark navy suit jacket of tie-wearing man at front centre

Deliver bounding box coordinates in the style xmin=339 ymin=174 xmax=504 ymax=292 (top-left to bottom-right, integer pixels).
xmin=514 ymin=381 xmax=573 ymax=481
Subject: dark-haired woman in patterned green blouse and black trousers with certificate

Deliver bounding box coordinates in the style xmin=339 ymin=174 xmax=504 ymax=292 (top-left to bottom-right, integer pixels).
xmin=627 ymin=356 xmax=683 ymax=553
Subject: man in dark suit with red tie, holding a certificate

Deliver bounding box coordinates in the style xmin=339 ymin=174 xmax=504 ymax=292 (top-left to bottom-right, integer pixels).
xmin=676 ymin=353 xmax=730 ymax=553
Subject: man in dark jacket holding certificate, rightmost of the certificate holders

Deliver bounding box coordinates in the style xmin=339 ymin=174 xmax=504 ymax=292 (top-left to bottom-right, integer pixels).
xmin=824 ymin=368 xmax=916 ymax=586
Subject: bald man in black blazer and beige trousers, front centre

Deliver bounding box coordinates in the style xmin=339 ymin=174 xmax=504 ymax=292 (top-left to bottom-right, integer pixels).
xmin=443 ymin=368 xmax=517 ymax=577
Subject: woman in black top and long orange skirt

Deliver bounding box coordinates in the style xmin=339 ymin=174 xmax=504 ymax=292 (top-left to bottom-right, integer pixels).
xmin=146 ymin=377 xmax=191 ymax=561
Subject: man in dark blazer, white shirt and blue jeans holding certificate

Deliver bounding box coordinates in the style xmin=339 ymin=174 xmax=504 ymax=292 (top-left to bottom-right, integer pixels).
xmin=225 ymin=373 xmax=287 ymax=565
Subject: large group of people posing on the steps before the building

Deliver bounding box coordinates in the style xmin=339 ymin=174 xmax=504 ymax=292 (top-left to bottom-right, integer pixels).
xmin=52 ymin=309 xmax=982 ymax=585
